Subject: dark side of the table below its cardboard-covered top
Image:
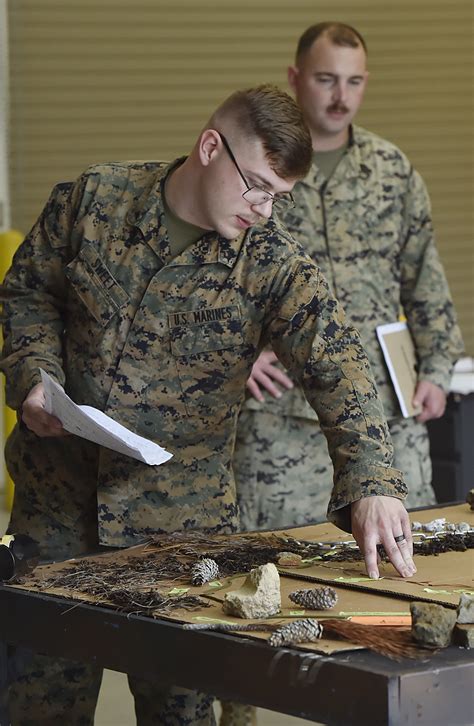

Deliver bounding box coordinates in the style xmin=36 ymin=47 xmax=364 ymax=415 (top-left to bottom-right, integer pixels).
xmin=0 ymin=585 xmax=474 ymax=726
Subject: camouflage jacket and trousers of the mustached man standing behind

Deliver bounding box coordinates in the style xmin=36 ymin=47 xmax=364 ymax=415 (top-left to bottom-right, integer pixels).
xmin=234 ymin=141 xmax=463 ymax=529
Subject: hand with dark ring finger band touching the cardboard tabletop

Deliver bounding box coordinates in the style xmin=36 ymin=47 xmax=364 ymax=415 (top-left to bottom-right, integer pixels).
xmin=351 ymin=496 xmax=416 ymax=579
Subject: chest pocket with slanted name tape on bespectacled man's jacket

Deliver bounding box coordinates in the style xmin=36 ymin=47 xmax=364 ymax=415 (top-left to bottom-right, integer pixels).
xmin=66 ymin=244 xmax=128 ymax=326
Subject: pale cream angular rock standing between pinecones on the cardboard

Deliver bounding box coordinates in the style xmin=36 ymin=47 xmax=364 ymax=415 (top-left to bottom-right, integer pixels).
xmin=222 ymin=562 xmax=281 ymax=619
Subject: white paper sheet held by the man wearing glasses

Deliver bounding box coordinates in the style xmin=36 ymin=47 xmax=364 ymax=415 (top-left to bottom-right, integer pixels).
xmin=40 ymin=369 xmax=173 ymax=466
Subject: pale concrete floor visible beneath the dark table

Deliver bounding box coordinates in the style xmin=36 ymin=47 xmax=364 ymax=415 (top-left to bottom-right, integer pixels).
xmin=0 ymin=506 xmax=313 ymax=726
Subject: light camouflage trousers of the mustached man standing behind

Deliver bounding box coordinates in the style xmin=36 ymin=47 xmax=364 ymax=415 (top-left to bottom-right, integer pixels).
xmin=233 ymin=409 xmax=436 ymax=531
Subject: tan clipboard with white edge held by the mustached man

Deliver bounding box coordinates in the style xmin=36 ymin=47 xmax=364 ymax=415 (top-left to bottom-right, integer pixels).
xmin=376 ymin=322 xmax=421 ymax=418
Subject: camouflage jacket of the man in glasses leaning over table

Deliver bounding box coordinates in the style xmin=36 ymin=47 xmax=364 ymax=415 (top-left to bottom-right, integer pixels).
xmin=1 ymin=163 xmax=406 ymax=546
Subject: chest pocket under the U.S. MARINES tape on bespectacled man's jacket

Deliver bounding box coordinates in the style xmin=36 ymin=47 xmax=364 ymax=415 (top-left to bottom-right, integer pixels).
xmin=168 ymin=305 xmax=252 ymax=418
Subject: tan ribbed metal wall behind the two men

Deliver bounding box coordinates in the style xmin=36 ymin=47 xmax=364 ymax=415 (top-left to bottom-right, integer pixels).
xmin=9 ymin=0 xmax=474 ymax=354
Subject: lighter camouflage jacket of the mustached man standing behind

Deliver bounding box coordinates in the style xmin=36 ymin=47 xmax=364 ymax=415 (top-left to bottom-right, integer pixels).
xmin=246 ymin=127 xmax=463 ymax=420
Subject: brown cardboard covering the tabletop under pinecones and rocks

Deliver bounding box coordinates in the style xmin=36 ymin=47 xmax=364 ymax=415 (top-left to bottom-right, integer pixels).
xmin=8 ymin=504 xmax=474 ymax=654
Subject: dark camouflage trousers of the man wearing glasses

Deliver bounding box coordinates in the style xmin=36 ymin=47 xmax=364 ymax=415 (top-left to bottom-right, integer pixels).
xmin=2 ymin=490 xmax=215 ymax=726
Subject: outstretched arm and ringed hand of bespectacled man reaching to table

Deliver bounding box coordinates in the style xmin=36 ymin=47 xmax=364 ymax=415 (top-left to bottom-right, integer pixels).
xmin=264 ymin=262 xmax=414 ymax=577
